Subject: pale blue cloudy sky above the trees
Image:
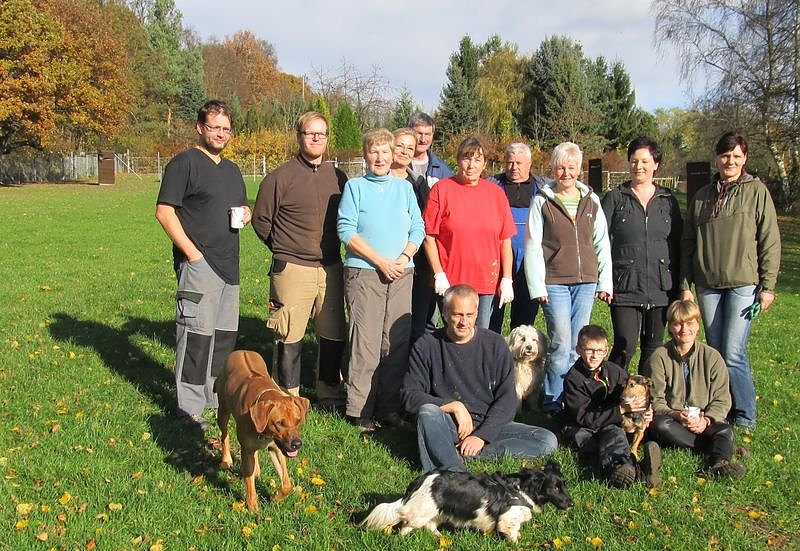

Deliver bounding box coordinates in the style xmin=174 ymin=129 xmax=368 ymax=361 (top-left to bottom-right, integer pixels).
xmin=175 ymin=0 xmax=690 ymax=111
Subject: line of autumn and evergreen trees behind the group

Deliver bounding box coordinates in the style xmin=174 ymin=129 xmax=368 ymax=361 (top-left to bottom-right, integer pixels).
xmin=0 ymin=0 xmax=800 ymax=206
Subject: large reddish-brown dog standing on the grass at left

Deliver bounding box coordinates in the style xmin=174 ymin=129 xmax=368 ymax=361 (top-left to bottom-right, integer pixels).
xmin=214 ymin=350 xmax=310 ymax=512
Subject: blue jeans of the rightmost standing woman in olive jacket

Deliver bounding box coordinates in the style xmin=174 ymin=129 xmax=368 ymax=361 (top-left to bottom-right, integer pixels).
xmin=697 ymin=285 xmax=756 ymax=428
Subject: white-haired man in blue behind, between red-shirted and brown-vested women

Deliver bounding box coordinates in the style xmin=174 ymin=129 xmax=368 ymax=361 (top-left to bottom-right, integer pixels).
xmin=489 ymin=143 xmax=545 ymax=333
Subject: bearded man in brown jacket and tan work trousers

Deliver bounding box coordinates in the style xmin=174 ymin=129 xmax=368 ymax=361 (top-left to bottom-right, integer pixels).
xmin=253 ymin=111 xmax=347 ymax=409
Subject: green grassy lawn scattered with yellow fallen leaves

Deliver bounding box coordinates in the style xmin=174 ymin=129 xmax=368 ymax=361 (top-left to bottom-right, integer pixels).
xmin=0 ymin=177 xmax=800 ymax=551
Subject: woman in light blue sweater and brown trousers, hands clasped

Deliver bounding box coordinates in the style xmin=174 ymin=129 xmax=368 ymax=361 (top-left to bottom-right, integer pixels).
xmin=337 ymin=128 xmax=425 ymax=431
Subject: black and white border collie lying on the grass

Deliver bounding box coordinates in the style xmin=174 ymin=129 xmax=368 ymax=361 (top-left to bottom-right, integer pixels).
xmin=361 ymin=461 xmax=573 ymax=542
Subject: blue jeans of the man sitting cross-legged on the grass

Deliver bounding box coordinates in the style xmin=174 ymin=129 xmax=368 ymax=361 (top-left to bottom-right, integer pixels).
xmin=417 ymin=404 xmax=558 ymax=473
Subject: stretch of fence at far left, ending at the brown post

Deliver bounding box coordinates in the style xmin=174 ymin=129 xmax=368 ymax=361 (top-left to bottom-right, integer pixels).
xmin=0 ymin=152 xmax=97 ymax=184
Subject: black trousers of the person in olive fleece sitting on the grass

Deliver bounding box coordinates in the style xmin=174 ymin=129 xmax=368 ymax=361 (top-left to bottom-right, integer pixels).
xmin=650 ymin=415 xmax=733 ymax=465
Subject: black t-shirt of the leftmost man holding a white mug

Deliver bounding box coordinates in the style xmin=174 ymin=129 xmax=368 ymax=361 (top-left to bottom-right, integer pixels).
xmin=156 ymin=147 xmax=247 ymax=285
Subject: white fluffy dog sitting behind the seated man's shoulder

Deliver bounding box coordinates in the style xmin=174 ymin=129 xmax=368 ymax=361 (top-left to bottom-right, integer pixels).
xmin=506 ymin=325 xmax=550 ymax=411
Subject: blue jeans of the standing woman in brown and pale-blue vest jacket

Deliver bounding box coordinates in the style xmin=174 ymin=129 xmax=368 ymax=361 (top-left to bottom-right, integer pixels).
xmin=542 ymin=283 xmax=597 ymax=412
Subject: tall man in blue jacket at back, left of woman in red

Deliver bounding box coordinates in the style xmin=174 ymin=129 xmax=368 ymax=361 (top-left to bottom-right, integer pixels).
xmin=408 ymin=112 xmax=453 ymax=345
